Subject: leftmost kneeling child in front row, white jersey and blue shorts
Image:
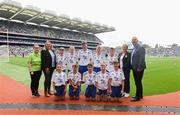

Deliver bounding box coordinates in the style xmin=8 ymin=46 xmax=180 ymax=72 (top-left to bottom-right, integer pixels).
xmin=52 ymin=64 xmax=67 ymax=101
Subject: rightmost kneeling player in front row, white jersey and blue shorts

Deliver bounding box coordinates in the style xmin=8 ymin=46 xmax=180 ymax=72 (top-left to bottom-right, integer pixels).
xmin=109 ymin=60 xmax=125 ymax=102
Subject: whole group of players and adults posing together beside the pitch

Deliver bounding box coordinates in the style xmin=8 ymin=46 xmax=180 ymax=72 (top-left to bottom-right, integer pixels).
xmin=28 ymin=37 xmax=146 ymax=101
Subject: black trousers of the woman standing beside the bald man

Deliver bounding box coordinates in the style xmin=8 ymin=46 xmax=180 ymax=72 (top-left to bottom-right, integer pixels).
xmin=123 ymin=68 xmax=130 ymax=93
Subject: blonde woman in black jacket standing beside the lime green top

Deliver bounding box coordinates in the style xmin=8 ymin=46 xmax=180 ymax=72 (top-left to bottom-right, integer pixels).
xmin=41 ymin=41 xmax=56 ymax=97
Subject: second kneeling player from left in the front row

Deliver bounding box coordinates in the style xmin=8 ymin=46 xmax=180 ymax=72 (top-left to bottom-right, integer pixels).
xmin=68 ymin=64 xmax=81 ymax=100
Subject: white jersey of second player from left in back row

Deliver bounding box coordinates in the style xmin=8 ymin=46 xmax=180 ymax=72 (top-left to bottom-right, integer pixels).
xmin=66 ymin=53 xmax=78 ymax=70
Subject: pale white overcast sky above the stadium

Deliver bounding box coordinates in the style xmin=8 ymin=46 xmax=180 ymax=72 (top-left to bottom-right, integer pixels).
xmin=0 ymin=0 xmax=180 ymax=46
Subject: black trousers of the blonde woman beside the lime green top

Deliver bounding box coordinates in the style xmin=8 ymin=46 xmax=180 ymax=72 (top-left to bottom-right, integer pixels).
xmin=43 ymin=68 xmax=55 ymax=92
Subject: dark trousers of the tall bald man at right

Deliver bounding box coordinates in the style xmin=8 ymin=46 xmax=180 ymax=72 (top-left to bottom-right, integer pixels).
xmin=133 ymin=69 xmax=144 ymax=98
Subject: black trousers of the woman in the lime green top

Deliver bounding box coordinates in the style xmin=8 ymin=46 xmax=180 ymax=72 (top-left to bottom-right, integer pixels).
xmin=30 ymin=71 xmax=42 ymax=95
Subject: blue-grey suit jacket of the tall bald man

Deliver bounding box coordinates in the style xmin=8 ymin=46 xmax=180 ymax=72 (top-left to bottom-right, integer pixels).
xmin=131 ymin=44 xmax=146 ymax=70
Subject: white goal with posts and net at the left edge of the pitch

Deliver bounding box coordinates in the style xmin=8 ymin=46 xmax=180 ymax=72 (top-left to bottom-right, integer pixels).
xmin=0 ymin=29 xmax=9 ymax=62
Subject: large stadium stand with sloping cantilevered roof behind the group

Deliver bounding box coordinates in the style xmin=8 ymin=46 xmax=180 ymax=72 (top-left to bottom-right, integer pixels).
xmin=0 ymin=0 xmax=115 ymax=53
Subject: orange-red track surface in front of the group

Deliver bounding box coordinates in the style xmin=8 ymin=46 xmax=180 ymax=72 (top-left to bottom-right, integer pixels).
xmin=0 ymin=75 xmax=180 ymax=114
